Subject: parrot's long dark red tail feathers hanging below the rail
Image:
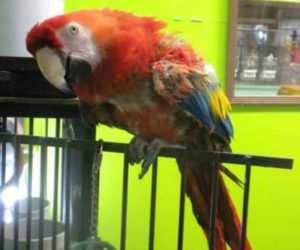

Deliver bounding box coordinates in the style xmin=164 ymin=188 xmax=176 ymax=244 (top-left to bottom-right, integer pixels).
xmin=180 ymin=162 xmax=251 ymax=250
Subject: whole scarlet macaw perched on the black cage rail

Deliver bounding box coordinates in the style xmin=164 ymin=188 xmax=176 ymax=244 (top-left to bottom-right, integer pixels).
xmin=26 ymin=8 xmax=251 ymax=250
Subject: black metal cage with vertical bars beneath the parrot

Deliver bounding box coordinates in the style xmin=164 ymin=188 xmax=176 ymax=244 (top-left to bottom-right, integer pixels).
xmin=0 ymin=58 xmax=292 ymax=250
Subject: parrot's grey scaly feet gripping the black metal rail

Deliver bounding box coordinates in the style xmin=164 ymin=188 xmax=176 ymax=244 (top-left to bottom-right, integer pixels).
xmin=128 ymin=136 xmax=165 ymax=179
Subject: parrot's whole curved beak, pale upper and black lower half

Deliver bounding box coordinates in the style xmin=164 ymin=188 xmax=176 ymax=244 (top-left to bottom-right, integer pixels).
xmin=35 ymin=47 xmax=92 ymax=93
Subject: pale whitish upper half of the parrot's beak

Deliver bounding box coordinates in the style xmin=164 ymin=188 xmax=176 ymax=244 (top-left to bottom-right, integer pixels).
xmin=35 ymin=47 xmax=69 ymax=92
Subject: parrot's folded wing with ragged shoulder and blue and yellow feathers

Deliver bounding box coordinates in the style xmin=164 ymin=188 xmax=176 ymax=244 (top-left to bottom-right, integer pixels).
xmin=152 ymin=60 xmax=233 ymax=144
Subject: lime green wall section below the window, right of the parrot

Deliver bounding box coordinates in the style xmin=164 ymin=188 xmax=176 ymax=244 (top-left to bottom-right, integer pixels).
xmin=231 ymin=105 xmax=300 ymax=250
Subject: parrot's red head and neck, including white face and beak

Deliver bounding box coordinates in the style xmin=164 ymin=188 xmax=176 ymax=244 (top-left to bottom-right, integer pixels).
xmin=26 ymin=9 xmax=165 ymax=99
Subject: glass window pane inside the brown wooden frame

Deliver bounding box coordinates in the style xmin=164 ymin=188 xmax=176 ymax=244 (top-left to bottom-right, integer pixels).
xmin=234 ymin=0 xmax=300 ymax=97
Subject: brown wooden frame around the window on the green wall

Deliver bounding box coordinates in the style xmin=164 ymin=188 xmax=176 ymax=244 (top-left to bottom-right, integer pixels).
xmin=226 ymin=0 xmax=300 ymax=104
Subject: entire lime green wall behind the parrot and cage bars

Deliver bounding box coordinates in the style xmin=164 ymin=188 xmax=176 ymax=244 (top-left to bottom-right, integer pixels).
xmin=66 ymin=0 xmax=300 ymax=250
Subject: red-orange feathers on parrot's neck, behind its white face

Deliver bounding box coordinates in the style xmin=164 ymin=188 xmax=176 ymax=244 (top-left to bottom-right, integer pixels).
xmin=74 ymin=9 xmax=165 ymax=102
